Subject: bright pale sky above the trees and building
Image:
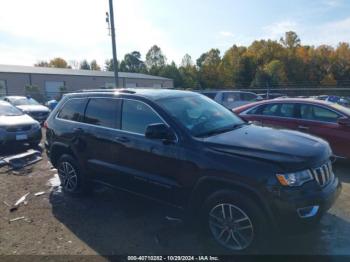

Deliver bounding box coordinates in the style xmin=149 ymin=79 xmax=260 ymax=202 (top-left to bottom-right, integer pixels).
xmin=0 ymin=0 xmax=350 ymax=68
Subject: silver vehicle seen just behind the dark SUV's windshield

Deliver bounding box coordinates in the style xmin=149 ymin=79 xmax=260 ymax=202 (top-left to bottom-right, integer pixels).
xmin=199 ymin=91 xmax=262 ymax=109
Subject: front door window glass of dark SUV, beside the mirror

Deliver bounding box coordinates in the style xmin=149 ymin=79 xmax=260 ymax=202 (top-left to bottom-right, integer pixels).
xmin=121 ymin=100 xmax=163 ymax=135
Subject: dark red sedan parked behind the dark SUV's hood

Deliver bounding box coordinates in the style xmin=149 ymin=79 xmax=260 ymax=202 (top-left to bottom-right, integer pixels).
xmin=233 ymin=98 xmax=350 ymax=159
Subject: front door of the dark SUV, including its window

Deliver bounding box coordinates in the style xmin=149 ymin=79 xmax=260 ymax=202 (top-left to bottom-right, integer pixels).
xmin=116 ymin=100 xmax=182 ymax=204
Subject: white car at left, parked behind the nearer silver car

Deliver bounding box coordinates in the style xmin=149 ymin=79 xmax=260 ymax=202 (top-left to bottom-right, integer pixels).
xmin=2 ymin=96 xmax=50 ymax=124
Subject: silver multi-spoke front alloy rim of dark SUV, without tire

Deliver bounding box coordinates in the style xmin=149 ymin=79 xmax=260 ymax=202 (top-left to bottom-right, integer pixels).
xmin=209 ymin=204 xmax=254 ymax=251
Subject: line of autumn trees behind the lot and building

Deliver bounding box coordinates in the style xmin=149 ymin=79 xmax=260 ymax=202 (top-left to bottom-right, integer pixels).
xmin=35 ymin=31 xmax=350 ymax=89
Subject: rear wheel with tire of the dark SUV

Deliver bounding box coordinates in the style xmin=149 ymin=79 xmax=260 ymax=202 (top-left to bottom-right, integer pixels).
xmin=57 ymin=154 xmax=91 ymax=195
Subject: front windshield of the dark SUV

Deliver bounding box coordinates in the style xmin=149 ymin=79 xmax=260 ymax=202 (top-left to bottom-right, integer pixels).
xmin=158 ymin=95 xmax=245 ymax=137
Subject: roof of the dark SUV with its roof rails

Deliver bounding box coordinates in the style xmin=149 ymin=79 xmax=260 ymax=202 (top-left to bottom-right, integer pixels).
xmin=66 ymin=88 xmax=198 ymax=101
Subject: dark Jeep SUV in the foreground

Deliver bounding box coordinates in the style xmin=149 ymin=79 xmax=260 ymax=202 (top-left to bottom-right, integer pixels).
xmin=45 ymin=89 xmax=341 ymax=252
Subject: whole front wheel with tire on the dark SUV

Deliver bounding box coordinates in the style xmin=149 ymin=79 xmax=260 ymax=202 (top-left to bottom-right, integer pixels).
xmin=203 ymin=190 xmax=267 ymax=254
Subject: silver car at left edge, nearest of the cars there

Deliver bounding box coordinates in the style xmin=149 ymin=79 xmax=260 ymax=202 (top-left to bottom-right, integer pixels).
xmin=0 ymin=101 xmax=41 ymax=146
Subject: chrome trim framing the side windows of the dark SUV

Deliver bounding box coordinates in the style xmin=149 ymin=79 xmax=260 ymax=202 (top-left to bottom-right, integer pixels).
xmin=55 ymin=96 xmax=179 ymax=143
